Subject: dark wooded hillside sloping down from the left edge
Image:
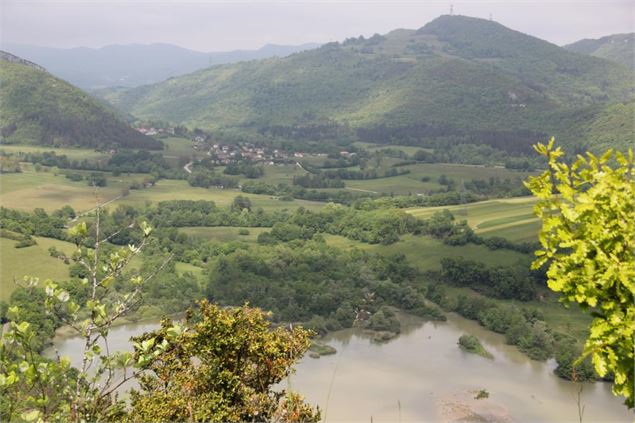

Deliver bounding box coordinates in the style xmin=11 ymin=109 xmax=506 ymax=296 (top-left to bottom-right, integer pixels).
xmin=0 ymin=52 xmax=163 ymax=149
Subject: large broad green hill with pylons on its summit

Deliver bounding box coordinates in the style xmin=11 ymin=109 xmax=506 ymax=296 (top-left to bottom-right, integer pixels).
xmin=102 ymin=16 xmax=634 ymax=153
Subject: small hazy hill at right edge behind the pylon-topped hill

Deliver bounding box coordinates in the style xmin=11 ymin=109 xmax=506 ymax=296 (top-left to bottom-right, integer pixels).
xmin=564 ymin=32 xmax=635 ymax=69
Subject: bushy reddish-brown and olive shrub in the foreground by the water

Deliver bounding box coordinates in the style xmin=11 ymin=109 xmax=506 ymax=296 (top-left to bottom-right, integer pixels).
xmin=130 ymin=301 xmax=320 ymax=422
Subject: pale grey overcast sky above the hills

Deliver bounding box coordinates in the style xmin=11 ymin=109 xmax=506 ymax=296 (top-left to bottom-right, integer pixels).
xmin=0 ymin=0 xmax=635 ymax=51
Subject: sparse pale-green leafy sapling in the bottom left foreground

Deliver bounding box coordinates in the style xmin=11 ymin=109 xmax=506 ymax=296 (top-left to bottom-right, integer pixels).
xmin=0 ymin=210 xmax=164 ymax=422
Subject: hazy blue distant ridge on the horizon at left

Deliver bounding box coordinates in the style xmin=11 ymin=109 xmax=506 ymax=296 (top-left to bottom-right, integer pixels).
xmin=3 ymin=44 xmax=318 ymax=89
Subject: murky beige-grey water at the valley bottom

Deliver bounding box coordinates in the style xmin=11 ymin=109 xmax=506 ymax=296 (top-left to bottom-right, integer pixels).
xmin=48 ymin=314 xmax=633 ymax=422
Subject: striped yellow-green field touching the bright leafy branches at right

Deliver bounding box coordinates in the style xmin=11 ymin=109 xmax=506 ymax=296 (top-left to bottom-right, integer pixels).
xmin=406 ymin=197 xmax=540 ymax=241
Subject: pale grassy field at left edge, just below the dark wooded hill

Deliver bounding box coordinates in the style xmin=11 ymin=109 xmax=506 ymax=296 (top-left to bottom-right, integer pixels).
xmin=0 ymin=166 xmax=146 ymax=211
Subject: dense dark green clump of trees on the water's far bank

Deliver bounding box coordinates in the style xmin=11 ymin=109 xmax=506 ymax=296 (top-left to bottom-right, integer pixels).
xmin=206 ymin=240 xmax=441 ymax=332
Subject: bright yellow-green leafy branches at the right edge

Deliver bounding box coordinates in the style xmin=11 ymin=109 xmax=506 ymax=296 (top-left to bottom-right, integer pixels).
xmin=527 ymin=138 xmax=635 ymax=407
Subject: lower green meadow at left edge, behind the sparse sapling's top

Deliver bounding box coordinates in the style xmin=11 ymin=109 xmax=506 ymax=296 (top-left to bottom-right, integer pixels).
xmin=0 ymin=237 xmax=75 ymax=300
